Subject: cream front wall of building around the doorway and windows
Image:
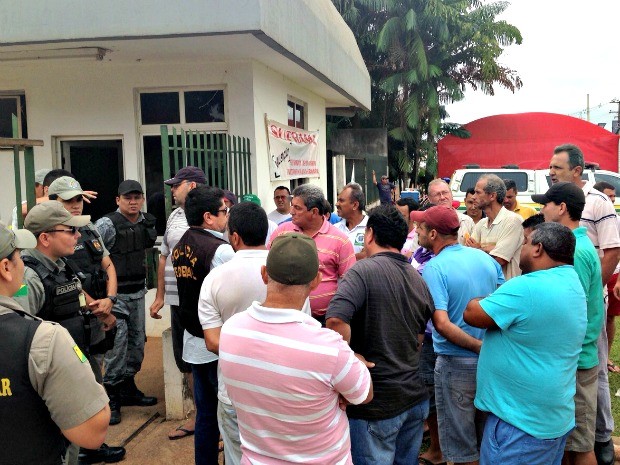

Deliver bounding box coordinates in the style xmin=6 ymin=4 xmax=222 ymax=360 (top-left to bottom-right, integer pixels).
xmin=0 ymin=61 xmax=256 ymax=220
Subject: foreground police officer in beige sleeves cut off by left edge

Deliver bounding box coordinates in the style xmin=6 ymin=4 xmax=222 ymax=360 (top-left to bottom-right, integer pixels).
xmin=0 ymin=223 xmax=110 ymax=465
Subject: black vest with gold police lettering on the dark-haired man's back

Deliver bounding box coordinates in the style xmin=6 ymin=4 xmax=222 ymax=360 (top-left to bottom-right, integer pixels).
xmin=171 ymin=226 xmax=225 ymax=337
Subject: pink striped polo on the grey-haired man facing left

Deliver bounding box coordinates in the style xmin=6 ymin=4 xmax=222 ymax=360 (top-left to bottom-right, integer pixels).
xmin=267 ymin=221 xmax=355 ymax=316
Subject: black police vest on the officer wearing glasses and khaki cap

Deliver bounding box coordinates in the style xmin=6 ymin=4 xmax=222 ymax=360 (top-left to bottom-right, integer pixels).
xmin=22 ymin=255 xmax=94 ymax=353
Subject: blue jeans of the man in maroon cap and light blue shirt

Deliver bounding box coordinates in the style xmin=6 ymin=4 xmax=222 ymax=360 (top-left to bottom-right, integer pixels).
xmin=435 ymin=355 xmax=484 ymax=463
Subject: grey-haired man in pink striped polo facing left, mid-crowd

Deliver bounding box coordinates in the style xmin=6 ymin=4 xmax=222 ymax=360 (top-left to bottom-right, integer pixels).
xmin=267 ymin=184 xmax=355 ymax=326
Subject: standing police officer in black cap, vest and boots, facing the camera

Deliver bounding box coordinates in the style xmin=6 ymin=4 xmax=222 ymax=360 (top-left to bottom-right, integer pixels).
xmin=96 ymin=180 xmax=157 ymax=424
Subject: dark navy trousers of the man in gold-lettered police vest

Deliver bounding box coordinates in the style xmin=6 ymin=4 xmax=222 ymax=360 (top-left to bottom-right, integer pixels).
xmin=191 ymin=361 xmax=220 ymax=465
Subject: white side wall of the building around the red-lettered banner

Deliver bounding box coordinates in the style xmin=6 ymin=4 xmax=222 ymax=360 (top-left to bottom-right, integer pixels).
xmin=253 ymin=62 xmax=327 ymax=212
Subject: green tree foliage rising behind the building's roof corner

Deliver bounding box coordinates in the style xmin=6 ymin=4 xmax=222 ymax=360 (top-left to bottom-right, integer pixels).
xmin=332 ymin=0 xmax=522 ymax=179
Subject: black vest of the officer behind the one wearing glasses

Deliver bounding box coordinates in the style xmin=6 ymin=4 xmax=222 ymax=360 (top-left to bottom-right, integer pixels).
xmin=66 ymin=226 xmax=108 ymax=299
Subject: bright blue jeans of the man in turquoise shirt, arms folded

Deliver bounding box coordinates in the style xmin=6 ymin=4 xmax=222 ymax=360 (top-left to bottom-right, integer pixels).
xmin=480 ymin=413 xmax=570 ymax=465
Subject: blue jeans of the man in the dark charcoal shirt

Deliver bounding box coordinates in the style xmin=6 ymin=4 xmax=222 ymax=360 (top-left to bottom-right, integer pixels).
xmin=349 ymin=400 xmax=428 ymax=465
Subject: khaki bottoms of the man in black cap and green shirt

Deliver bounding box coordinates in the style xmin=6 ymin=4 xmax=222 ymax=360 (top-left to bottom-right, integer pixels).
xmin=566 ymin=365 xmax=598 ymax=452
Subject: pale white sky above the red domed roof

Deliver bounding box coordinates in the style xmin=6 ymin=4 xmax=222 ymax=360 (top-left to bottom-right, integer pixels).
xmin=446 ymin=0 xmax=620 ymax=130
